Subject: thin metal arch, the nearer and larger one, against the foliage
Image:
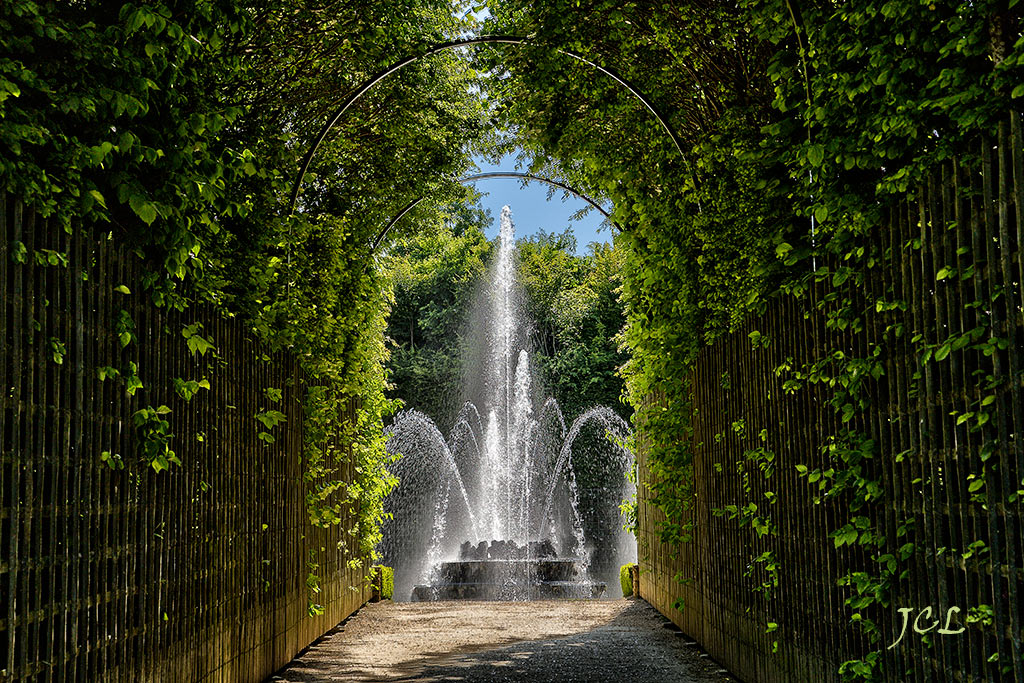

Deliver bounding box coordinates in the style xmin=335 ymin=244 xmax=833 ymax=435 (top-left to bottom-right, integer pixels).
xmin=289 ymin=36 xmax=686 ymax=214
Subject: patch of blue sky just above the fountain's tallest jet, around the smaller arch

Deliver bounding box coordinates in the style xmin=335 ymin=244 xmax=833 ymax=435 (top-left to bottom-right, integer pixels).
xmin=473 ymin=157 xmax=611 ymax=255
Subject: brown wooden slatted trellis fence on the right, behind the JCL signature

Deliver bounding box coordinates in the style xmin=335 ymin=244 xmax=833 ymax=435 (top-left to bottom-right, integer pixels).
xmin=639 ymin=115 xmax=1024 ymax=683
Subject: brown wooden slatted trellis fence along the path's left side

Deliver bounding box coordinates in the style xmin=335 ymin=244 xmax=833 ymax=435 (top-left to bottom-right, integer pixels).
xmin=0 ymin=195 xmax=370 ymax=681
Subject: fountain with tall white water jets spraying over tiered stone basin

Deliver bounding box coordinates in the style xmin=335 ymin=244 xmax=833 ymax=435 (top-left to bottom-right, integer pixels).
xmin=381 ymin=206 xmax=636 ymax=600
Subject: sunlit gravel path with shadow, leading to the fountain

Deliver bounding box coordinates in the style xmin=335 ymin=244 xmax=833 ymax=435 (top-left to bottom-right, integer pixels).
xmin=269 ymin=600 xmax=725 ymax=683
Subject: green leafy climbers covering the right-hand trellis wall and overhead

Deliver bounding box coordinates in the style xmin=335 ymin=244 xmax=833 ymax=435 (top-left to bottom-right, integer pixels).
xmin=481 ymin=0 xmax=1024 ymax=680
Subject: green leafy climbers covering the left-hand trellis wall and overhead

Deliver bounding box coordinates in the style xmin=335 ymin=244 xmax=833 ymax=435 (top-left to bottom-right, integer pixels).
xmin=0 ymin=0 xmax=491 ymax=610
